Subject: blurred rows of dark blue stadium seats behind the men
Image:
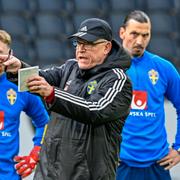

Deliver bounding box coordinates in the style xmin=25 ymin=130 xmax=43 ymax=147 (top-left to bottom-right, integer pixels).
xmin=0 ymin=0 xmax=180 ymax=70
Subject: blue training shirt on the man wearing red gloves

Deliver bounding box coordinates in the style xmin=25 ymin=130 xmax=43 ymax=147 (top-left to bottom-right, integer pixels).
xmin=0 ymin=73 xmax=49 ymax=180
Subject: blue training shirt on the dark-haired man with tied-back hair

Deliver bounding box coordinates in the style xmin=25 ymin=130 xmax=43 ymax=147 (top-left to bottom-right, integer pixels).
xmin=120 ymin=51 xmax=180 ymax=167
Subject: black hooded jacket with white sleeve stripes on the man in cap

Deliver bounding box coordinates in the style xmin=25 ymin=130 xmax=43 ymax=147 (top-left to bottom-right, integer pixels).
xmin=34 ymin=40 xmax=132 ymax=180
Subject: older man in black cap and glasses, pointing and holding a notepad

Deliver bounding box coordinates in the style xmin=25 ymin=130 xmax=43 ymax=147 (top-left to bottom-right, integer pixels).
xmin=0 ymin=18 xmax=132 ymax=180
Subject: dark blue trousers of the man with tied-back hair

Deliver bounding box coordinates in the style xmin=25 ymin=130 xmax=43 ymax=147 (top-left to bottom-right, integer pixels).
xmin=116 ymin=162 xmax=171 ymax=180
